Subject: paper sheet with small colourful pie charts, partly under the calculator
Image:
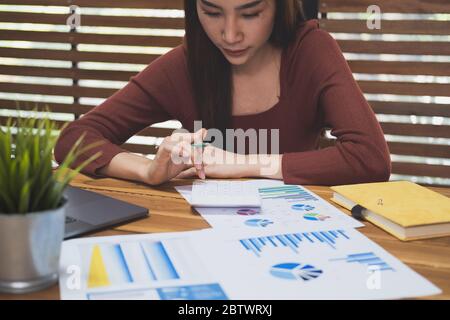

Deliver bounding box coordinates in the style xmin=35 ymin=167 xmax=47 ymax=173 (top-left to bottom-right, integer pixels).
xmin=176 ymin=180 xmax=363 ymax=230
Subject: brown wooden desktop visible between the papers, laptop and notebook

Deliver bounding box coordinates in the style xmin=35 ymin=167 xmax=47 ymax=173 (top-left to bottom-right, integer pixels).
xmin=0 ymin=175 xmax=450 ymax=299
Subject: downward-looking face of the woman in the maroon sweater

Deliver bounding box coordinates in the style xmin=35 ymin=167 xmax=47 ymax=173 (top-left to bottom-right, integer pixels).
xmin=197 ymin=0 xmax=275 ymax=66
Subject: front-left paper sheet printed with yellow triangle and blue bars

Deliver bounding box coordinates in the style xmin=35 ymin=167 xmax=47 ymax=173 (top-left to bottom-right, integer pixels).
xmin=60 ymin=233 xmax=228 ymax=300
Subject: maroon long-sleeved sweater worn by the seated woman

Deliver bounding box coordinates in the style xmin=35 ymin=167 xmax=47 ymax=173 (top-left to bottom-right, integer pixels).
xmin=55 ymin=20 xmax=391 ymax=185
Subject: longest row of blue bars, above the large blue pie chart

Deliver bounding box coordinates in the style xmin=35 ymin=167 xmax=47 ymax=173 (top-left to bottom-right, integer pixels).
xmin=239 ymin=230 xmax=350 ymax=257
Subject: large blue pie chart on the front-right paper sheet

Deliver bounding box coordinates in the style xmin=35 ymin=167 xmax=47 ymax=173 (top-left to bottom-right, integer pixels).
xmin=270 ymin=262 xmax=323 ymax=281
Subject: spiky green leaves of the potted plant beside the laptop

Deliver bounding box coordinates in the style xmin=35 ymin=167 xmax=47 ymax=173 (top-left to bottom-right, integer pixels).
xmin=0 ymin=111 xmax=100 ymax=214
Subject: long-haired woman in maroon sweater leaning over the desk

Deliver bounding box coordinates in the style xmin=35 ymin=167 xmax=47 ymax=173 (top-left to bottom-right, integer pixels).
xmin=55 ymin=0 xmax=391 ymax=185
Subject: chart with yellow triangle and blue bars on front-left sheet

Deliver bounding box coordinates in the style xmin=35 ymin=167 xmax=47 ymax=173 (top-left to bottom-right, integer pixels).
xmin=79 ymin=240 xmax=211 ymax=289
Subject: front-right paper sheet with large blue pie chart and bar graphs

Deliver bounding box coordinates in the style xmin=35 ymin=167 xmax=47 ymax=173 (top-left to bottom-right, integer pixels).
xmin=192 ymin=228 xmax=440 ymax=299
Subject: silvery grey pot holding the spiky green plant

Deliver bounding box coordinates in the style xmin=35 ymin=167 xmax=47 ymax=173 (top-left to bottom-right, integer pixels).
xmin=0 ymin=199 xmax=67 ymax=293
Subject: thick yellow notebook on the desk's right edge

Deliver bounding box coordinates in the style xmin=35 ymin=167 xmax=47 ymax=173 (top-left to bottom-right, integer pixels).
xmin=331 ymin=181 xmax=450 ymax=240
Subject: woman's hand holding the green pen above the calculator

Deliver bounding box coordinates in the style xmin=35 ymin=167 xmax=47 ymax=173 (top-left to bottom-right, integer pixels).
xmin=144 ymin=129 xmax=207 ymax=185
